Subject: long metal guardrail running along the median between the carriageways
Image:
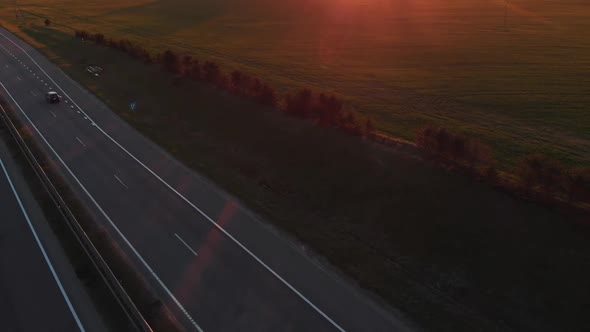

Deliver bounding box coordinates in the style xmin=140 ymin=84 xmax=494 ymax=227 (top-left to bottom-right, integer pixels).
xmin=0 ymin=105 xmax=153 ymax=332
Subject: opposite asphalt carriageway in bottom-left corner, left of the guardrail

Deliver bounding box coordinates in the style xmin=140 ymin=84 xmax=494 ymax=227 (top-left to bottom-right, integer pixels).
xmin=0 ymin=141 xmax=107 ymax=332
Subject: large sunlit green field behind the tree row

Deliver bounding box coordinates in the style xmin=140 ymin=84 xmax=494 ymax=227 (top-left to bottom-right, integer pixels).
xmin=5 ymin=0 xmax=590 ymax=165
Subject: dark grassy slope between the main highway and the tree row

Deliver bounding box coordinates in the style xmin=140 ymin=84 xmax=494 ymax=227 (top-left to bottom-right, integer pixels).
xmin=8 ymin=25 xmax=590 ymax=331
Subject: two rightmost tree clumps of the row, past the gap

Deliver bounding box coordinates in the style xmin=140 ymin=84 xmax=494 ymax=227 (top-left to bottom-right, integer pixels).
xmin=416 ymin=125 xmax=590 ymax=203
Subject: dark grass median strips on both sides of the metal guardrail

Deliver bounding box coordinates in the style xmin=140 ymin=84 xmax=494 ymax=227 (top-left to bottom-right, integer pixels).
xmin=0 ymin=97 xmax=181 ymax=332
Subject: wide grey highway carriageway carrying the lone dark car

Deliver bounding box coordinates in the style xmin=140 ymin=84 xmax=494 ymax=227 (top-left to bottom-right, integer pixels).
xmin=0 ymin=29 xmax=410 ymax=331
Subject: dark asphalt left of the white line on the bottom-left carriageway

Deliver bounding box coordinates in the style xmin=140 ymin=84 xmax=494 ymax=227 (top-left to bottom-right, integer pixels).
xmin=0 ymin=157 xmax=85 ymax=331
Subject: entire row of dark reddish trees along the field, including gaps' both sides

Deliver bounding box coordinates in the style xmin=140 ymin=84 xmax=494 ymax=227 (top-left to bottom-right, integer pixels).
xmin=75 ymin=30 xmax=590 ymax=209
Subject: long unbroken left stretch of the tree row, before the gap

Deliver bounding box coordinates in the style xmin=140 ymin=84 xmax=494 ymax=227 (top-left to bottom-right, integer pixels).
xmin=75 ymin=30 xmax=375 ymax=138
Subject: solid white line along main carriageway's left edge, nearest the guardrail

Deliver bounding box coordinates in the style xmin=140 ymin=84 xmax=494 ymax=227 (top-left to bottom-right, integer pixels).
xmin=0 ymin=83 xmax=204 ymax=332
